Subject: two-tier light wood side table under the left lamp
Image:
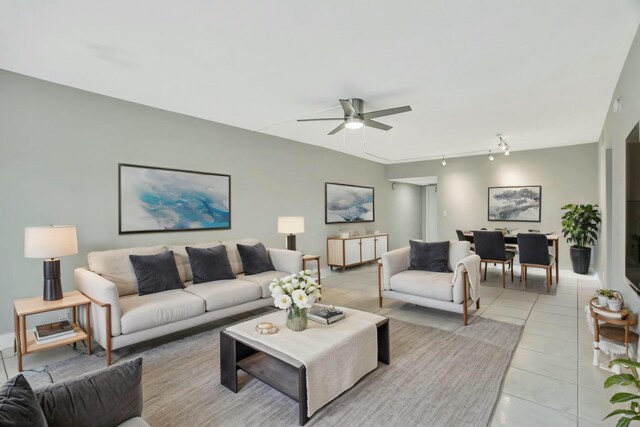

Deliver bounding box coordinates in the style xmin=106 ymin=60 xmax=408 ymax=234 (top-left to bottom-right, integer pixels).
xmin=13 ymin=291 xmax=91 ymax=372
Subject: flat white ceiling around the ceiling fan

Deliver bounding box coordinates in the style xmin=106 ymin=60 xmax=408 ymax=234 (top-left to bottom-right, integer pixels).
xmin=0 ymin=0 xmax=640 ymax=163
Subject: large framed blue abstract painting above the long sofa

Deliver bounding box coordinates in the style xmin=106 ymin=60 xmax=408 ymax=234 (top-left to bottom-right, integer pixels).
xmin=118 ymin=164 xmax=231 ymax=234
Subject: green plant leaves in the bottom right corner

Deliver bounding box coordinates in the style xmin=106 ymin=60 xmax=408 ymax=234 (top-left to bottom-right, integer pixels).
xmin=603 ymin=359 xmax=640 ymax=427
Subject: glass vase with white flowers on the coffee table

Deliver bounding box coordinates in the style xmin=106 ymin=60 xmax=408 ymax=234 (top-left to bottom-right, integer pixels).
xmin=269 ymin=270 xmax=322 ymax=332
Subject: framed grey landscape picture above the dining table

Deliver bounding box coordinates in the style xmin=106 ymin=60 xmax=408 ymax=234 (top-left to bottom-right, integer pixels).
xmin=488 ymin=185 xmax=542 ymax=222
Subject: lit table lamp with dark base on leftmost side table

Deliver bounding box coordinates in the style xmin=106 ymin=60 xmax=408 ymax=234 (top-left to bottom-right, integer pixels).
xmin=24 ymin=225 xmax=78 ymax=301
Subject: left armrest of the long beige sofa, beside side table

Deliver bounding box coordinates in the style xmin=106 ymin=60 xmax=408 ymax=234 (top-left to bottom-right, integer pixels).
xmin=74 ymin=268 xmax=122 ymax=340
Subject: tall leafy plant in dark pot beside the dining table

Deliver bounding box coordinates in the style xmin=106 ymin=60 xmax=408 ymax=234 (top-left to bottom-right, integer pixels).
xmin=562 ymin=204 xmax=601 ymax=274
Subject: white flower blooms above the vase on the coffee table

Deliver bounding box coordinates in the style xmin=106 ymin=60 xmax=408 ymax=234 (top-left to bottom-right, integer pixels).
xmin=269 ymin=270 xmax=322 ymax=311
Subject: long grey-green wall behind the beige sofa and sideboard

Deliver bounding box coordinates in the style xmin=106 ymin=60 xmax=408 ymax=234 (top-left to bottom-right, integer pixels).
xmin=0 ymin=70 xmax=421 ymax=340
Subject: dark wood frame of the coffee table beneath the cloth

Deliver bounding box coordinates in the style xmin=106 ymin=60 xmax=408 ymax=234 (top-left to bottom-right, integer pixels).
xmin=220 ymin=319 xmax=391 ymax=425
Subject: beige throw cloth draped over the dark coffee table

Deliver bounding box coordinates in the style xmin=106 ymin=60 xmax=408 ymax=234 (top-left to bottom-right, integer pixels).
xmin=227 ymin=308 xmax=384 ymax=417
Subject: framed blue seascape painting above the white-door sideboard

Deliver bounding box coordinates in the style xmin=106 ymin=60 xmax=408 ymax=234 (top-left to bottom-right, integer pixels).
xmin=324 ymin=182 xmax=376 ymax=224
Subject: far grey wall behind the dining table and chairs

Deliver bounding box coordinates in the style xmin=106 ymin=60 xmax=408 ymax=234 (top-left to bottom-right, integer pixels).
xmin=387 ymin=143 xmax=598 ymax=268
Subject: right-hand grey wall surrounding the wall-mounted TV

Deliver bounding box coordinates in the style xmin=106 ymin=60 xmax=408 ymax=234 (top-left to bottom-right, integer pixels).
xmin=599 ymin=27 xmax=640 ymax=312
